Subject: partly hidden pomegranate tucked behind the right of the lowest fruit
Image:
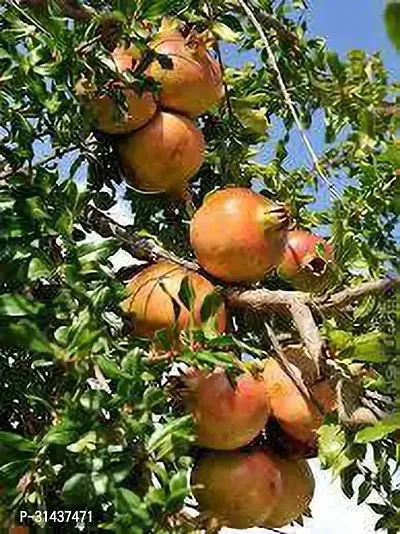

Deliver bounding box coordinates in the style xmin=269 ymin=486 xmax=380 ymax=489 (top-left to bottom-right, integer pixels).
xmin=262 ymin=456 xmax=315 ymax=528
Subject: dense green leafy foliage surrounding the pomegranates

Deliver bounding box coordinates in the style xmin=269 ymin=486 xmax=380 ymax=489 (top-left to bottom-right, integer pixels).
xmin=0 ymin=0 xmax=400 ymax=533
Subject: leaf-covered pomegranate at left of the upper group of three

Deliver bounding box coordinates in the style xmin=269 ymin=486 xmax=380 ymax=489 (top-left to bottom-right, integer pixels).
xmin=77 ymin=46 xmax=157 ymax=134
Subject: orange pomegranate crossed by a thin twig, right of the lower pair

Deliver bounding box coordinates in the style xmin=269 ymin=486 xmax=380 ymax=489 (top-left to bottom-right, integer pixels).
xmin=263 ymin=349 xmax=336 ymax=447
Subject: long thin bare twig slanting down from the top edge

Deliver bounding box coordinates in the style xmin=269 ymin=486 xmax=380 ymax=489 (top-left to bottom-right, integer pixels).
xmin=237 ymin=0 xmax=340 ymax=200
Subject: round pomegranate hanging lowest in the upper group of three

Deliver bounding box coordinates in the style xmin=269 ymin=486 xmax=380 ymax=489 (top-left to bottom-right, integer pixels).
xmin=118 ymin=111 xmax=205 ymax=197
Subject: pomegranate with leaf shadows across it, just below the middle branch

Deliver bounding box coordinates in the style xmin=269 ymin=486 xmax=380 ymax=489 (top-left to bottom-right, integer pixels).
xmin=122 ymin=261 xmax=226 ymax=336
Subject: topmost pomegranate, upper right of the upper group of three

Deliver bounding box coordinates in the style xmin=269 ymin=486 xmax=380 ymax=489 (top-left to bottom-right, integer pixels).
xmin=147 ymin=31 xmax=224 ymax=117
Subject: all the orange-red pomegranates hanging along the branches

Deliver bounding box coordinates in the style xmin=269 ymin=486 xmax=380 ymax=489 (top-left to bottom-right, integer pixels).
xmin=78 ymin=16 xmax=336 ymax=528
